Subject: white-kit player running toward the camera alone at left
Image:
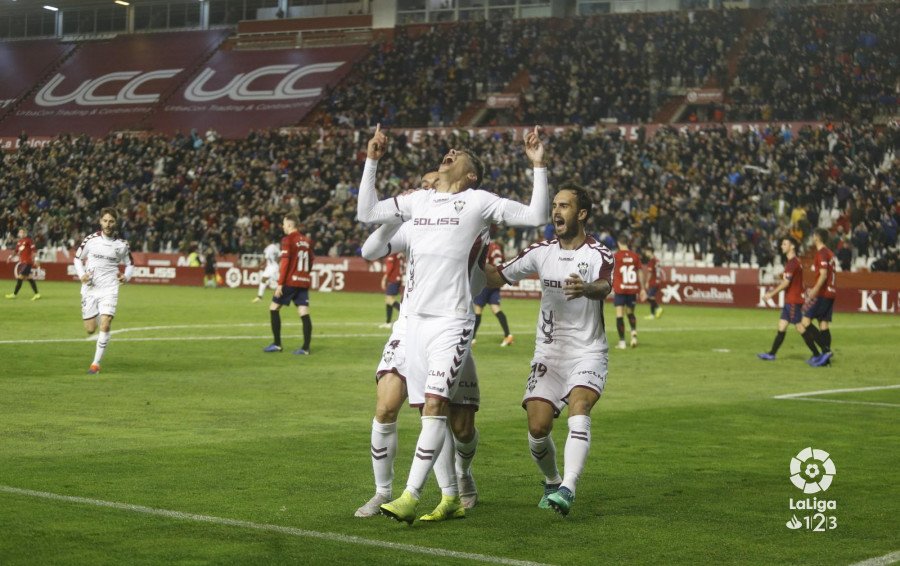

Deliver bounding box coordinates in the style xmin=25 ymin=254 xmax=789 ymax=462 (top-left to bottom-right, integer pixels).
xmin=75 ymin=208 xmax=134 ymax=374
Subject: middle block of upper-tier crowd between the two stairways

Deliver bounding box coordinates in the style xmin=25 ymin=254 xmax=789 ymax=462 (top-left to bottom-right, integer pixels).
xmin=516 ymin=10 xmax=742 ymax=125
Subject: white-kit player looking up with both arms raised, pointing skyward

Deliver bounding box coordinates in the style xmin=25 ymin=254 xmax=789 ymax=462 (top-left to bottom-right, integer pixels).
xmin=357 ymin=128 xmax=549 ymax=523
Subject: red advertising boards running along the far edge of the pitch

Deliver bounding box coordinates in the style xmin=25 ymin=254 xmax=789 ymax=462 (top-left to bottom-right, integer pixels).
xmin=0 ymin=254 xmax=900 ymax=314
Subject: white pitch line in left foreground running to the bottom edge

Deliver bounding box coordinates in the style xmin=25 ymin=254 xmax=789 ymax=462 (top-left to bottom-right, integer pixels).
xmin=0 ymin=485 xmax=547 ymax=566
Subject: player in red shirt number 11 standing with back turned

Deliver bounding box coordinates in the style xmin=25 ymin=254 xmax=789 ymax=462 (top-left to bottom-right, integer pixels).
xmin=263 ymin=214 xmax=315 ymax=356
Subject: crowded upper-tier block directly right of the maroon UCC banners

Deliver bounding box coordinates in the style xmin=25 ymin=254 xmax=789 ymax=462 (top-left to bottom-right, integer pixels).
xmin=313 ymin=20 xmax=543 ymax=128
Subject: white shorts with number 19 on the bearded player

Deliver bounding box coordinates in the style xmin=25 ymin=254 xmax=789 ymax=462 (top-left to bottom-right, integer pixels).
xmin=522 ymin=354 xmax=609 ymax=417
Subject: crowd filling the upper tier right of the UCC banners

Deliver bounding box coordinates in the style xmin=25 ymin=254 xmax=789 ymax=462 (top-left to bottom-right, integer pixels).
xmin=307 ymin=2 xmax=900 ymax=128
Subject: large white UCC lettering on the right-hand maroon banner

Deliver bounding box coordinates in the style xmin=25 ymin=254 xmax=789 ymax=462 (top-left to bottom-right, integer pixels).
xmin=184 ymin=61 xmax=344 ymax=102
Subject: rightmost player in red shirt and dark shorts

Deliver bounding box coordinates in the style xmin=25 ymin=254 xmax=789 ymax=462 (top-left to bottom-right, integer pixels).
xmin=800 ymin=228 xmax=837 ymax=367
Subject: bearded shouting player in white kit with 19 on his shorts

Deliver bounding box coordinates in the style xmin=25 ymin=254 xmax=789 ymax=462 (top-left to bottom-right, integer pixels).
xmin=486 ymin=183 xmax=615 ymax=516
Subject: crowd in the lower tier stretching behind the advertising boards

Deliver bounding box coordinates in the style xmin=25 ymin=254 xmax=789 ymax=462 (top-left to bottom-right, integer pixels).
xmin=0 ymin=124 xmax=900 ymax=268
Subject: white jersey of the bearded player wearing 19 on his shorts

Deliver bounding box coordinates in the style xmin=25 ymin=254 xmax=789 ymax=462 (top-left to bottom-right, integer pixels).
xmin=499 ymin=236 xmax=615 ymax=358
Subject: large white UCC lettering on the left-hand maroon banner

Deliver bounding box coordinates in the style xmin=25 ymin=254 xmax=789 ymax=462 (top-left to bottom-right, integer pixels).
xmin=34 ymin=69 xmax=182 ymax=106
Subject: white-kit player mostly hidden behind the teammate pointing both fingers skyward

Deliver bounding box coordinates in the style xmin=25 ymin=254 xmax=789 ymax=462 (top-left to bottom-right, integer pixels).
xmin=356 ymin=203 xmax=485 ymax=521
